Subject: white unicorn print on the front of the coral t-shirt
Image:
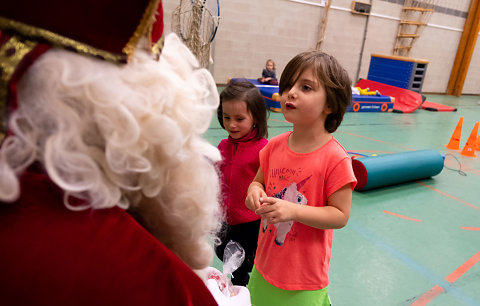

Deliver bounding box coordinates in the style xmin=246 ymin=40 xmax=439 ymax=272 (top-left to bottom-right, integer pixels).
xmin=262 ymin=176 xmax=310 ymax=246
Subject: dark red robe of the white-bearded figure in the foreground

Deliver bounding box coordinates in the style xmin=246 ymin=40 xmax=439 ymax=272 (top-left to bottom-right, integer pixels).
xmin=0 ymin=172 xmax=217 ymax=306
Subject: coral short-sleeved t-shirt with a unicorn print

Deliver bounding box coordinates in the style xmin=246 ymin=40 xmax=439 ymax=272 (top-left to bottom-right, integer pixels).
xmin=255 ymin=132 xmax=357 ymax=290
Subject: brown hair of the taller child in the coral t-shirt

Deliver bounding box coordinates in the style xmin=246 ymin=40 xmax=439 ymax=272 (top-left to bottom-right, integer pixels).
xmin=279 ymin=51 xmax=352 ymax=133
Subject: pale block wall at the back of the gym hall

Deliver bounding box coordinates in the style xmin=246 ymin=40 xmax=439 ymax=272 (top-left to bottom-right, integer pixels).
xmin=163 ymin=0 xmax=480 ymax=94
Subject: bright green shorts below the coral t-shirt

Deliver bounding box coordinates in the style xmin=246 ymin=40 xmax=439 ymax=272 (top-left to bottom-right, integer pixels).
xmin=247 ymin=266 xmax=331 ymax=306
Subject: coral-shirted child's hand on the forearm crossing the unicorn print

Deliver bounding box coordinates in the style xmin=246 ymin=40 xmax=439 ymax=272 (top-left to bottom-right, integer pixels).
xmin=255 ymin=197 xmax=299 ymax=224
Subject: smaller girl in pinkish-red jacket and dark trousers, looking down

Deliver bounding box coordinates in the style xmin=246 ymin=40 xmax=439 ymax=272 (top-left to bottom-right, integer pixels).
xmin=215 ymin=81 xmax=268 ymax=286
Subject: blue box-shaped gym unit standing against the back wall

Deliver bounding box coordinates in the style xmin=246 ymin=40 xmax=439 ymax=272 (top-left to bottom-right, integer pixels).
xmin=367 ymin=54 xmax=428 ymax=93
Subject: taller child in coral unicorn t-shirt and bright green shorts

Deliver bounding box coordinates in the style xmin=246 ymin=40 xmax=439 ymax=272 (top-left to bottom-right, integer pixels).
xmin=245 ymin=51 xmax=356 ymax=306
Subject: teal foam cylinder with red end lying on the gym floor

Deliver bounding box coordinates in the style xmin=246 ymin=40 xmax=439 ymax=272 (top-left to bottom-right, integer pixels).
xmin=352 ymin=150 xmax=444 ymax=191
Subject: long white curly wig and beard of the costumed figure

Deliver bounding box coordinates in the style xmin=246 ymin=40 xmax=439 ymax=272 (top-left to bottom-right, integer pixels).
xmin=0 ymin=34 xmax=221 ymax=269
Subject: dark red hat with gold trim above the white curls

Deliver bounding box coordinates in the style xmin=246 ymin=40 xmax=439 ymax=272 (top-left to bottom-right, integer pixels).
xmin=0 ymin=0 xmax=163 ymax=141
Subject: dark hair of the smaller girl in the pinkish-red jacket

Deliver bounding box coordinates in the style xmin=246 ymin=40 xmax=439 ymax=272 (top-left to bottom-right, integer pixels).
xmin=217 ymin=80 xmax=268 ymax=139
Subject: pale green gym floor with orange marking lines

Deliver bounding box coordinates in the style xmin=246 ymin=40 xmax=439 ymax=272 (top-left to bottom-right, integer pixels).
xmin=204 ymin=93 xmax=480 ymax=306
